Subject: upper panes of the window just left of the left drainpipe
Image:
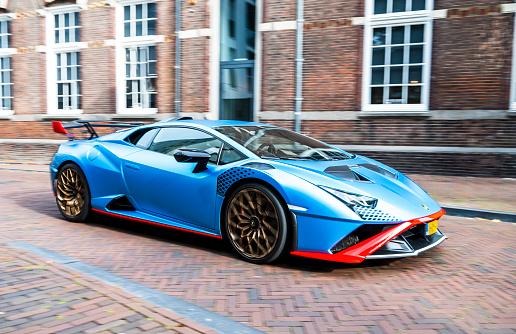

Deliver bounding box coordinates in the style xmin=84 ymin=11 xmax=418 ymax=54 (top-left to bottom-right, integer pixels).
xmin=124 ymin=2 xmax=157 ymax=37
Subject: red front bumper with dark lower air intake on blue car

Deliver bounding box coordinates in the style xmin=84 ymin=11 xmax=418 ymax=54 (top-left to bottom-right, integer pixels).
xmin=291 ymin=209 xmax=446 ymax=263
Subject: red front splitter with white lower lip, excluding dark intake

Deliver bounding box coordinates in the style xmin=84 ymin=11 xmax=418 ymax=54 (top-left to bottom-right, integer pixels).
xmin=290 ymin=209 xmax=446 ymax=263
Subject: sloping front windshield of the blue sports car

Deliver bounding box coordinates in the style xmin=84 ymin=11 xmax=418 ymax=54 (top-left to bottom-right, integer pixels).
xmin=216 ymin=125 xmax=354 ymax=161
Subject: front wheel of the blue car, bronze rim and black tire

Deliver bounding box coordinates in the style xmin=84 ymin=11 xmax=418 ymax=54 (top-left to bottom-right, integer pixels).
xmin=222 ymin=183 xmax=289 ymax=264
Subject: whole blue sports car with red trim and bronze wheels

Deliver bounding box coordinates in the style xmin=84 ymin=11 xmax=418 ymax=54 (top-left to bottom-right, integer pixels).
xmin=50 ymin=117 xmax=446 ymax=263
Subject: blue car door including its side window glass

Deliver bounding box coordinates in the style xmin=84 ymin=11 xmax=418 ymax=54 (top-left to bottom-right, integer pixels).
xmin=122 ymin=127 xmax=246 ymax=229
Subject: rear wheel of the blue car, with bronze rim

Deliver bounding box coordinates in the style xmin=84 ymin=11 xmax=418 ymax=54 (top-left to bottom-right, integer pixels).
xmin=55 ymin=163 xmax=91 ymax=222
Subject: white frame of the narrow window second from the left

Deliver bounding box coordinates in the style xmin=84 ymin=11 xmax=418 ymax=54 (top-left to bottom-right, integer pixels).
xmin=46 ymin=5 xmax=85 ymax=116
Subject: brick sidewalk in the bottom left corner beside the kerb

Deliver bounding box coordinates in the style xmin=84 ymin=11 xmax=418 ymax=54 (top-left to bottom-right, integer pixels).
xmin=0 ymin=244 xmax=216 ymax=334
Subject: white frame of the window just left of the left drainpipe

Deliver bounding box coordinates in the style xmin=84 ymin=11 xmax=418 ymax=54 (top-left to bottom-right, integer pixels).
xmin=115 ymin=0 xmax=158 ymax=115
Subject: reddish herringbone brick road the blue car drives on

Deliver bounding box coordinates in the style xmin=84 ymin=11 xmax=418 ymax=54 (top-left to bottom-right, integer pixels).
xmin=0 ymin=170 xmax=516 ymax=334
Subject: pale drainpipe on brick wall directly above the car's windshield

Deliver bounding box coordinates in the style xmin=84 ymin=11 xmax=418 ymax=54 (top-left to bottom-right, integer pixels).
xmin=294 ymin=0 xmax=305 ymax=132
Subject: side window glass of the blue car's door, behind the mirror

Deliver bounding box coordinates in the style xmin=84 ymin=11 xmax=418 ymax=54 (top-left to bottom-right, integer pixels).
xmin=149 ymin=127 xmax=222 ymax=164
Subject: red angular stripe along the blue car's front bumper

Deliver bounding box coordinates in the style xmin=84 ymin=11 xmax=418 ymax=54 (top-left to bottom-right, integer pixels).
xmin=290 ymin=209 xmax=446 ymax=263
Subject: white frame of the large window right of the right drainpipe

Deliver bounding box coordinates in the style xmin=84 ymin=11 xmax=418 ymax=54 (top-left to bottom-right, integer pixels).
xmin=362 ymin=0 xmax=433 ymax=115
